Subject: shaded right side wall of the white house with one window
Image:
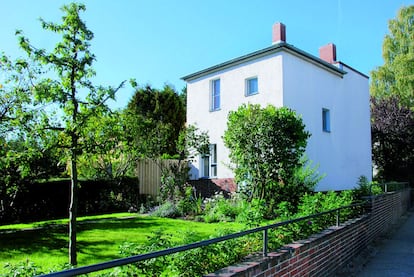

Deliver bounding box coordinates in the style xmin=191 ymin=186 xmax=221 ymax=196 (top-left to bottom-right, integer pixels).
xmin=283 ymin=55 xmax=372 ymax=190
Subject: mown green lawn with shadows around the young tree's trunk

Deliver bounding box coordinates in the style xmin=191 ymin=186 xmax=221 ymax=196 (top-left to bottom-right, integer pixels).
xmin=0 ymin=213 xmax=243 ymax=273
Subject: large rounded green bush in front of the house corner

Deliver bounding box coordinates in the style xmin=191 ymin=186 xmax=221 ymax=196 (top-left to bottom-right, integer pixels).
xmin=224 ymin=104 xmax=310 ymax=212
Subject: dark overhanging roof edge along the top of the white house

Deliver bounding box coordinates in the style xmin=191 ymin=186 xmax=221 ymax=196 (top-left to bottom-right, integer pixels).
xmin=181 ymin=42 xmax=346 ymax=81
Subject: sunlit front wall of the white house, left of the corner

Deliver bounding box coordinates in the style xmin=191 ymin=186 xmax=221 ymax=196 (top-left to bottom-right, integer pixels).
xmin=187 ymin=54 xmax=283 ymax=179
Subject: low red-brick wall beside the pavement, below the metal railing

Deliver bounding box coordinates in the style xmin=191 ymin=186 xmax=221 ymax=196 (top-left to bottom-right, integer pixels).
xmin=207 ymin=190 xmax=411 ymax=277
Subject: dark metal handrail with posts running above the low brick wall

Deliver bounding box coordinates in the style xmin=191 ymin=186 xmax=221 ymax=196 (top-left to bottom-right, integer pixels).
xmin=41 ymin=202 xmax=367 ymax=277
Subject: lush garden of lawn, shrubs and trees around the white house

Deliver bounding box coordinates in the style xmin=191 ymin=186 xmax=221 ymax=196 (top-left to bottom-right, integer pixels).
xmin=0 ymin=3 xmax=414 ymax=276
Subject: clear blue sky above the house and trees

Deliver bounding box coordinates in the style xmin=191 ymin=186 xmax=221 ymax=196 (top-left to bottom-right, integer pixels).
xmin=0 ymin=0 xmax=414 ymax=108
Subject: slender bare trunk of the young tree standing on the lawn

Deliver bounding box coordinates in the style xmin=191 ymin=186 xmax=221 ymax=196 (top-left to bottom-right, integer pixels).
xmin=69 ymin=148 xmax=78 ymax=265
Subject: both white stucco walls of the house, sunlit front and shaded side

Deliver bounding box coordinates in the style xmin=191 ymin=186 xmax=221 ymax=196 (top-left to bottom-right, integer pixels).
xmin=187 ymin=51 xmax=371 ymax=190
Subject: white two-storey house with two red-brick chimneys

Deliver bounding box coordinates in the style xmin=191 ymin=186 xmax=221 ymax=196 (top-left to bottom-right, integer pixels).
xmin=183 ymin=23 xmax=372 ymax=190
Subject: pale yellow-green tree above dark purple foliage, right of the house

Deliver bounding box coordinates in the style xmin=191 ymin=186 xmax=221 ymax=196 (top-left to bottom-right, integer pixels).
xmin=370 ymin=5 xmax=414 ymax=110
